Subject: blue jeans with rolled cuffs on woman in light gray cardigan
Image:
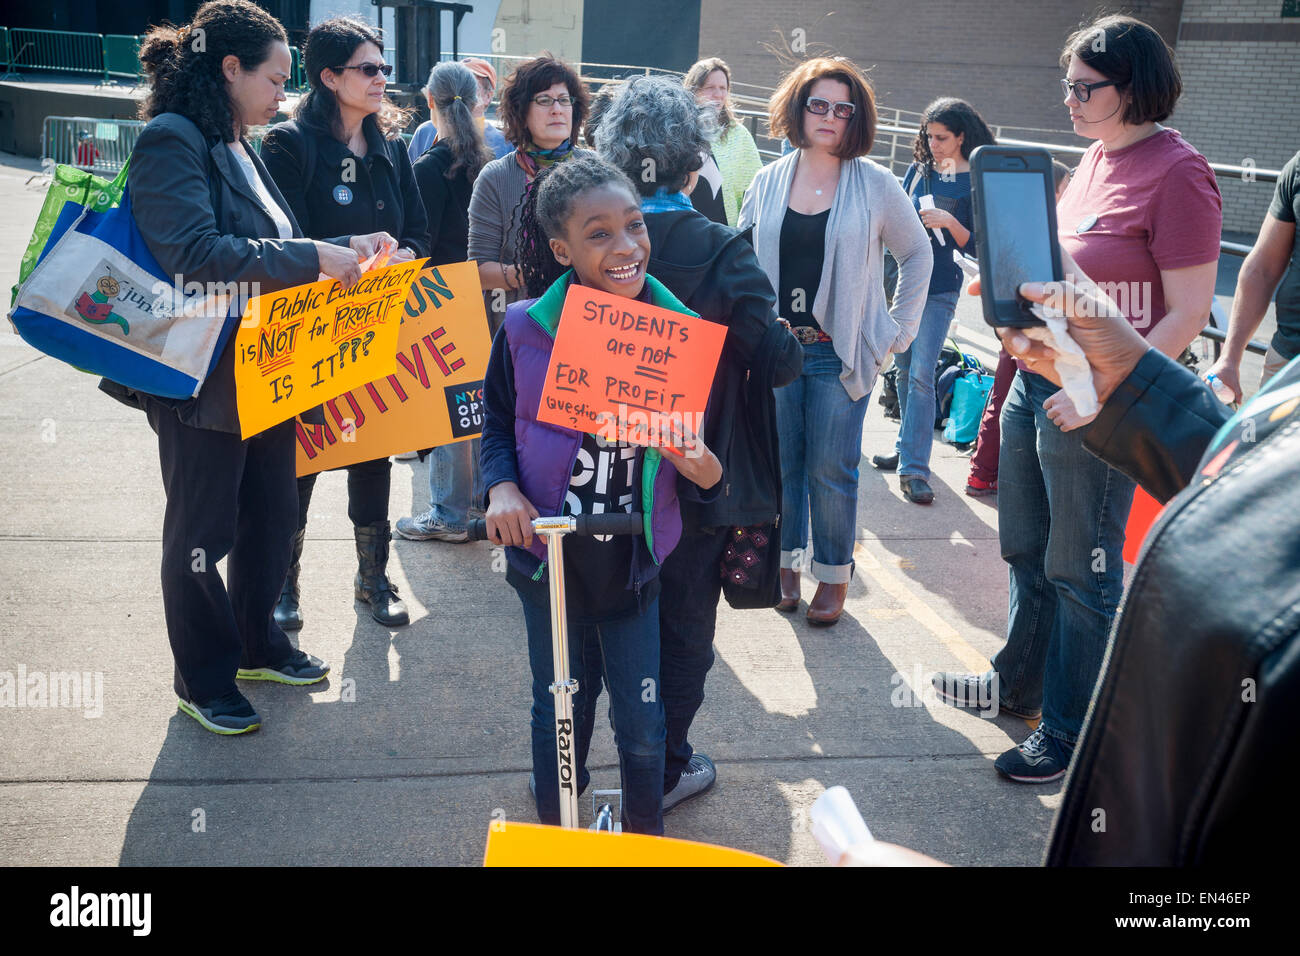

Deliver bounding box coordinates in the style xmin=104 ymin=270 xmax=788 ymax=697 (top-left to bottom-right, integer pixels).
xmin=775 ymin=342 xmax=870 ymax=584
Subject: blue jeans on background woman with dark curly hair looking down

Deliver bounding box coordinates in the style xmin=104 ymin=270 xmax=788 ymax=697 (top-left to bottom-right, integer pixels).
xmin=894 ymin=286 xmax=958 ymax=481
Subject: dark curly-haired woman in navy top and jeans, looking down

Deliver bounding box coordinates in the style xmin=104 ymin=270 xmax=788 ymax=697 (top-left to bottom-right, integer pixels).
xmin=871 ymin=96 xmax=993 ymax=505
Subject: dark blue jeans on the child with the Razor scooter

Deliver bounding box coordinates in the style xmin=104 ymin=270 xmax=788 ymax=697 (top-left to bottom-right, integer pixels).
xmin=516 ymin=592 xmax=666 ymax=835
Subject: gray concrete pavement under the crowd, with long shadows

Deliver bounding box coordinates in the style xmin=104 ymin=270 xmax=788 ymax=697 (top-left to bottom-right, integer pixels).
xmin=0 ymin=151 xmax=1258 ymax=865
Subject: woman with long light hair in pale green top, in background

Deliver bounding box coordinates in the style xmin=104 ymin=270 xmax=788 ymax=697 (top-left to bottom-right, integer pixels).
xmin=683 ymin=56 xmax=763 ymax=226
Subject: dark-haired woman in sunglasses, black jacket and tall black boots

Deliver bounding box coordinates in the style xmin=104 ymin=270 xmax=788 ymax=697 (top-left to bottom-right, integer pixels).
xmin=261 ymin=17 xmax=429 ymax=630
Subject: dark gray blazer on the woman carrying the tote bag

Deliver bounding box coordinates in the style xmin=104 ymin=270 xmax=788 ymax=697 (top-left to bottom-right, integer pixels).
xmin=100 ymin=113 xmax=335 ymax=434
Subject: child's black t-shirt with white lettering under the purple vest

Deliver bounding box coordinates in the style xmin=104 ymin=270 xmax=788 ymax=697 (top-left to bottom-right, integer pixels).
xmin=501 ymin=434 xmax=659 ymax=624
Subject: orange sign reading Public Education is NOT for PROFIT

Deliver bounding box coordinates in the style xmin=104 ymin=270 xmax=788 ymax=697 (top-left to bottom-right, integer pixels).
xmin=235 ymin=259 xmax=425 ymax=438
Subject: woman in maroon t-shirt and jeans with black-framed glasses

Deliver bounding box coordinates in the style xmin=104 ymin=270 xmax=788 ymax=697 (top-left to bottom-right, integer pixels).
xmin=933 ymin=16 xmax=1222 ymax=783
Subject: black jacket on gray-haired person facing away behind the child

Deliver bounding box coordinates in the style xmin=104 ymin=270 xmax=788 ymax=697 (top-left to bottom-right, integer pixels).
xmin=645 ymin=209 xmax=803 ymax=531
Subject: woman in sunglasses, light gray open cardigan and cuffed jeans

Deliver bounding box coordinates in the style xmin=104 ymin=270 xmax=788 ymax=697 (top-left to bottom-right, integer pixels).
xmin=740 ymin=57 xmax=931 ymax=624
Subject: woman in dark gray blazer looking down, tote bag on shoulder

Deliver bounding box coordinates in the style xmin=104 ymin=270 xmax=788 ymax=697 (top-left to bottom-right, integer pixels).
xmin=103 ymin=0 xmax=386 ymax=734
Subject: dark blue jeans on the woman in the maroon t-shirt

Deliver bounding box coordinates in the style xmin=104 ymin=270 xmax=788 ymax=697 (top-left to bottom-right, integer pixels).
xmin=993 ymin=371 xmax=1135 ymax=745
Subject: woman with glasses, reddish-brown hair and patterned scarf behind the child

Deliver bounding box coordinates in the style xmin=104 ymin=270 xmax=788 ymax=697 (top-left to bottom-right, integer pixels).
xmin=469 ymin=53 xmax=592 ymax=332
